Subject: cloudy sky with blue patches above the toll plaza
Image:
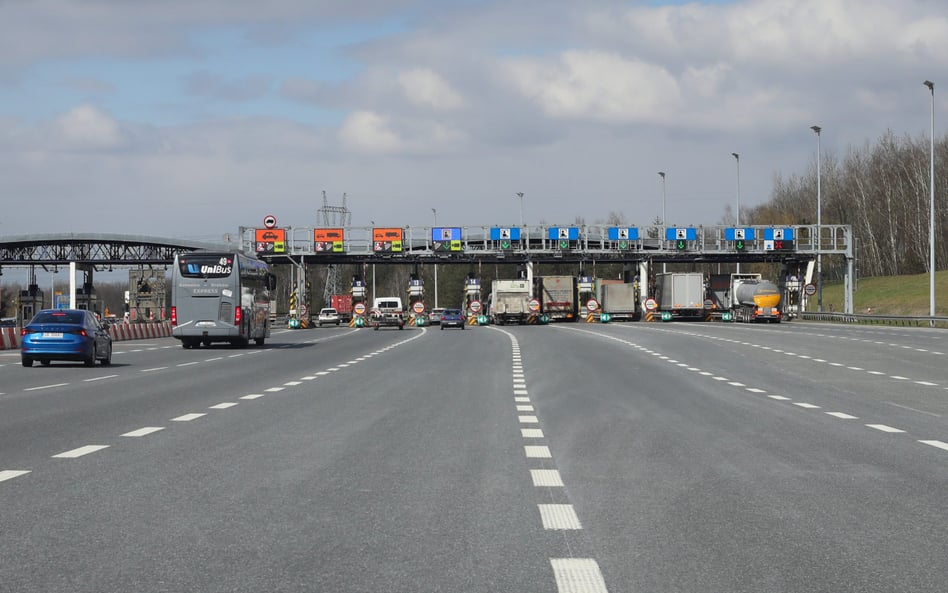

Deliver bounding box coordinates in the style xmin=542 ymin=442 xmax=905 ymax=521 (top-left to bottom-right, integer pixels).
xmin=0 ymin=0 xmax=948 ymax=242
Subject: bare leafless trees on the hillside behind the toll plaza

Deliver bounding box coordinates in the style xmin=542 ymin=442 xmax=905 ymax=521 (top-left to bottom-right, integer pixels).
xmin=741 ymin=131 xmax=948 ymax=276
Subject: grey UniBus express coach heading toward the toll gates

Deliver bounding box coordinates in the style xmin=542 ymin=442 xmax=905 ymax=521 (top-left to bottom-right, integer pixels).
xmin=171 ymin=251 xmax=276 ymax=348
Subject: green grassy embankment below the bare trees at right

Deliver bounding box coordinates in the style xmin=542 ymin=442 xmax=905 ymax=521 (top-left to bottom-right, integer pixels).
xmin=809 ymin=270 xmax=948 ymax=317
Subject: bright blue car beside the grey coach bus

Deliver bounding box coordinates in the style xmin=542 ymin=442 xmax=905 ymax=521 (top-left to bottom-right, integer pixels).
xmin=20 ymin=309 xmax=112 ymax=367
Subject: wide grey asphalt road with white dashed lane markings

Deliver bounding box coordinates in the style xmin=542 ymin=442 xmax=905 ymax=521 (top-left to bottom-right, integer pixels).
xmin=0 ymin=323 xmax=948 ymax=593
